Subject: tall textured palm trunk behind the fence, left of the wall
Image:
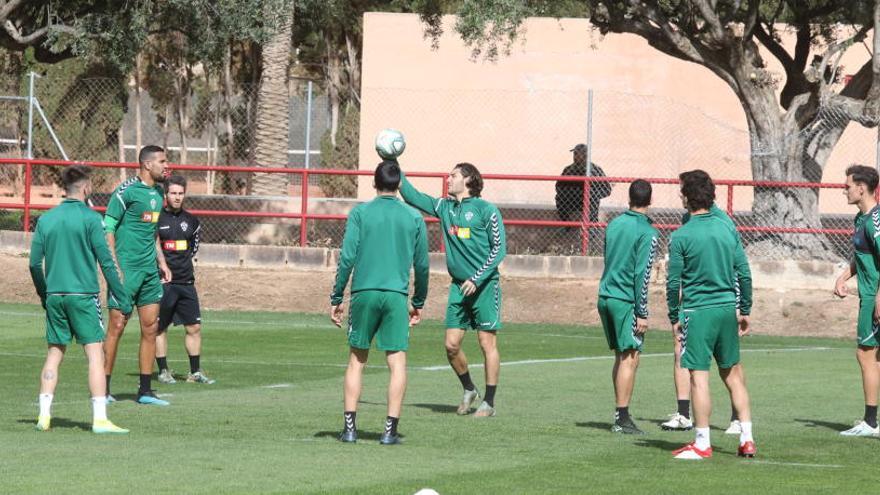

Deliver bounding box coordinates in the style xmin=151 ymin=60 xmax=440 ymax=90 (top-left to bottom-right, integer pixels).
xmin=251 ymin=2 xmax=293 ymax=195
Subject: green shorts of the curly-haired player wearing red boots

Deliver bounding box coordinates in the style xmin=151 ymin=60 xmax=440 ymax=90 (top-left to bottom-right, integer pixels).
xmin=679 ymin=306 xmax=739 ymax=371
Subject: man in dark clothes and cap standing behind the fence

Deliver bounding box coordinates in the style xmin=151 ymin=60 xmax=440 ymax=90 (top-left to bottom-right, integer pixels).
xmin=556 ymin=144 xmax=611 ymax=245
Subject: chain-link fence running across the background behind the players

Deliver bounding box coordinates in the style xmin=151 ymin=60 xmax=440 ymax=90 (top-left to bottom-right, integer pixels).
xmin=0 ymin=79 xmax=876 ymax=259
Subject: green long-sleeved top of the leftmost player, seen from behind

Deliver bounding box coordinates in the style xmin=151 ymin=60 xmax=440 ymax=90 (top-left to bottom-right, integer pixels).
xmin=30 ymin=199 xmax=130 ymax=302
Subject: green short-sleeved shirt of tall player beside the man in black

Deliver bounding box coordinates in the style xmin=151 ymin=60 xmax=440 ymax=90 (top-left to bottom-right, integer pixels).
xmin=106 ymin=177 xmax=164 ymax=270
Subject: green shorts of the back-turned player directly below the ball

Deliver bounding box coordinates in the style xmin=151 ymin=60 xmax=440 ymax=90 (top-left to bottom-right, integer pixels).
xmin=348 ymin=290 xmax=409 ymax=351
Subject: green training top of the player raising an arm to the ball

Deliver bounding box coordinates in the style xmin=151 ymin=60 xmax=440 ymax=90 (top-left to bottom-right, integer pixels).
xmin=400 ymin=171 xmax=507 ymax=287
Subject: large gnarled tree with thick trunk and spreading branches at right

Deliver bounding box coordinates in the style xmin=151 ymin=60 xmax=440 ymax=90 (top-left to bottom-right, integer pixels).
xmin=425 ymin=0 xmax=880 ymax=258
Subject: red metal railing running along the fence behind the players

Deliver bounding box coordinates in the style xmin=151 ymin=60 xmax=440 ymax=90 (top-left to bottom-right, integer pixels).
xmin=0 ymin=158 xmax=852 ymax=254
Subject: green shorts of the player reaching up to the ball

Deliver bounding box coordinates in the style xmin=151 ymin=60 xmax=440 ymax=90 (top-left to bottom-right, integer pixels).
xmin=446 ymin=280 xmax=501 ymax=332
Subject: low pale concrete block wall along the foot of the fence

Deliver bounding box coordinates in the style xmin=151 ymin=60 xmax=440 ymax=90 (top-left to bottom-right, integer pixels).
xmin=0 ymin=231 xmax=842 ymax=292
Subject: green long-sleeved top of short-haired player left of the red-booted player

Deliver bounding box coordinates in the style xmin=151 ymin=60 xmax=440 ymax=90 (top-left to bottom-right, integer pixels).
xmin=599 ymin=210 xmax=660 ymax=318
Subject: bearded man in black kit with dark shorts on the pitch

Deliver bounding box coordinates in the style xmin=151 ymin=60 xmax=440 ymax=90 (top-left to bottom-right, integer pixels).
xmin=156 ymin=175 xmax=214 ymax=384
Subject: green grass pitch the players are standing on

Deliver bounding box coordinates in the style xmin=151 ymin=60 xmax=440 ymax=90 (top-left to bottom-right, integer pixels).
xmin=0 ymin=305 xmax=868 ymax=494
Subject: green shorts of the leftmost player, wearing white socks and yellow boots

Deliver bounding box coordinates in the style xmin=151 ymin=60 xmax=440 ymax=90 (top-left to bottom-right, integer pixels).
xmin=46 ymin=294 xmax=104 ymax=345
